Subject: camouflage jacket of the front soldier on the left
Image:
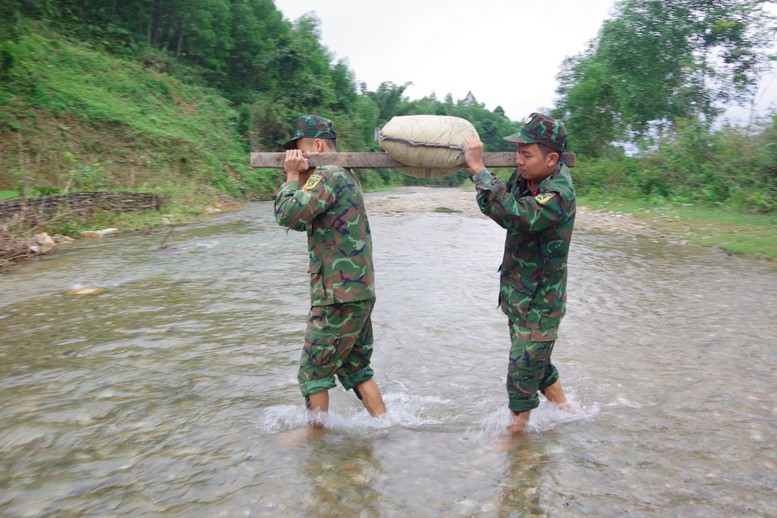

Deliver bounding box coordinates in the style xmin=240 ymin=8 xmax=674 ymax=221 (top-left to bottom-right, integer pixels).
xmin=275 ymin=166 xmax=375 ymax=306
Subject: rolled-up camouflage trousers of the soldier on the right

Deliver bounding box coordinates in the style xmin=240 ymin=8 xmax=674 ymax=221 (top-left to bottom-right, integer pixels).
xmin=507 ymin=322 xmax=558 ymax=414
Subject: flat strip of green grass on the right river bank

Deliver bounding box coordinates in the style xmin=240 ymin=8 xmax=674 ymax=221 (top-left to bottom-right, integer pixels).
xmin=578 ymin=197 xmax=777 ymax=260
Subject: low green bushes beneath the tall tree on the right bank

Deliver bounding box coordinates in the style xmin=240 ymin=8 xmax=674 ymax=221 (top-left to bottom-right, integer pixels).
xmin=572 ymin=115 xmax=777 ymax=213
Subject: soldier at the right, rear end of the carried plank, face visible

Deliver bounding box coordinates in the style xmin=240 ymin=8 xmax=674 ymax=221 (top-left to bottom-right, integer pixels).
xmin=463 ymin=113 xmax=575 ymax=432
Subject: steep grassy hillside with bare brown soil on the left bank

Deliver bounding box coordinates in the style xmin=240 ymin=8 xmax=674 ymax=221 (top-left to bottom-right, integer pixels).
xmin=0 ymin=24 xmax=277 ymax=204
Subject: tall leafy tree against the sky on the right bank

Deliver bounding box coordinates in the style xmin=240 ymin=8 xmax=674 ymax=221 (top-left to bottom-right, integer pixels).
xmin=557 ymin=0 xmax=776 ymax=153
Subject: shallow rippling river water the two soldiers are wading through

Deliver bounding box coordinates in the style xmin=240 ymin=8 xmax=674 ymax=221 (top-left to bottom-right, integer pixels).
xmin=0 ymin=194 xmax=777 ymax=517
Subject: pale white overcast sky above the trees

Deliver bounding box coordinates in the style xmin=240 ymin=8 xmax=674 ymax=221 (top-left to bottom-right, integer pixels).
xmin=275 ymin=0 xmax=777 ymax=124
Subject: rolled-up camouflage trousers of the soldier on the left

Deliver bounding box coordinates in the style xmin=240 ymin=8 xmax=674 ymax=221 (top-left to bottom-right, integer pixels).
xmin=297 ymin=299 xmax=375 ymax=397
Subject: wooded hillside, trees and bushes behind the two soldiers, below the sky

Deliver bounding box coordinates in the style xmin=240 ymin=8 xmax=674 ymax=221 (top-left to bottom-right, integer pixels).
xmin=0 ymin=0 xmax=777 ymax=212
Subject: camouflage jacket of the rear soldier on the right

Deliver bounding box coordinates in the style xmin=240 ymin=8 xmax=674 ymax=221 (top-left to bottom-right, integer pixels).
xmin=472 ymin=164 xmax=575 ymax=340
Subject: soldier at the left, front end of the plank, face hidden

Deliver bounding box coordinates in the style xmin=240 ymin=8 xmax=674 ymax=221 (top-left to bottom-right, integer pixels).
xmin=275 ymin=115 xmax=386 ymax=422
